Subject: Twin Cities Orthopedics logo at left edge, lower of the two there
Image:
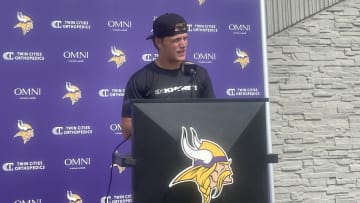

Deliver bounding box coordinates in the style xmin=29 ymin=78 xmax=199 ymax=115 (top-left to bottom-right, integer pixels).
xmin=2 ymin=161 xmax=46 ymax=172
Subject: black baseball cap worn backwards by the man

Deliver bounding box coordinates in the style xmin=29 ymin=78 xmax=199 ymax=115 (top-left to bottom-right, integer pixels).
xmin=146 ymin=13 xmax=188 ymax=39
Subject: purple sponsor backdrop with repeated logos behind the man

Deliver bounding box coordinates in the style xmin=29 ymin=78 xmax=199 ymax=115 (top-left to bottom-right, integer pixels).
xmin=0 ymin=0 xmax=266 ymax=203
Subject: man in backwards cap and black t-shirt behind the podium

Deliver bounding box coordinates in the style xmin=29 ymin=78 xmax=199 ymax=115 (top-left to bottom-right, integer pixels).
xmin=121 ymin=13 xmax=215 ymax=138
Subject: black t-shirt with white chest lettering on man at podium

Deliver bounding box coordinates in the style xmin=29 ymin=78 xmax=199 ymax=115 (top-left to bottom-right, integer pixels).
xmin=122 ymin=62 xmax=215 ymax=117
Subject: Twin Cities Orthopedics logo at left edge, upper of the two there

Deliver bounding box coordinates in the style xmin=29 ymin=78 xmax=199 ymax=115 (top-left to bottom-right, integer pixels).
xmin=2 ymin=51 xmax=45 ymax=61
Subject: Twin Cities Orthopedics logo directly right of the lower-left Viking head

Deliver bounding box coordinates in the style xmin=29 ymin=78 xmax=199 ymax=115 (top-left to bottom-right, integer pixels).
xmin=51 ymin=125 xmax=93 ymax=135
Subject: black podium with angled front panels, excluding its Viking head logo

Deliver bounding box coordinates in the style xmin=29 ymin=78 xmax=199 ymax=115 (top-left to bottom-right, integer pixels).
xmin=132 ymin=99 xmax=270 ymax=203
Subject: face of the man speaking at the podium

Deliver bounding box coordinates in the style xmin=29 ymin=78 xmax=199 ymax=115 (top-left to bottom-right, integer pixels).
xmin=157 ymin=33 xmax=188 ymax=62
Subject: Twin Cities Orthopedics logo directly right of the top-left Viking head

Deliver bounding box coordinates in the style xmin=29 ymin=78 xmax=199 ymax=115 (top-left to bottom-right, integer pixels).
xmin=51 ymin=20 xmax=91 ymax=30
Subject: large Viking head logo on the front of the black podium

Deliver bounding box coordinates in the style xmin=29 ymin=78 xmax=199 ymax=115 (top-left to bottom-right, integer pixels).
xmin=169 ymin=127 xmax=233 ymax=203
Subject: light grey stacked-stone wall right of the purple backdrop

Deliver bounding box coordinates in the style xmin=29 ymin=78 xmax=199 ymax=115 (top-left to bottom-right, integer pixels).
xmin=267 ymin=0 xmax=360 ymax=203
